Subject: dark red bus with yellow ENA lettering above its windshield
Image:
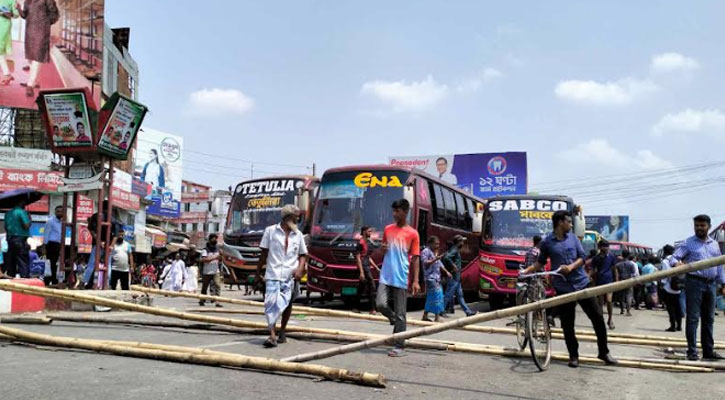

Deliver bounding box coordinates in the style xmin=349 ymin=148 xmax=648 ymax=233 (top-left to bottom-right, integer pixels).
xmin=307 ymin=165 xmax=483 ymax=304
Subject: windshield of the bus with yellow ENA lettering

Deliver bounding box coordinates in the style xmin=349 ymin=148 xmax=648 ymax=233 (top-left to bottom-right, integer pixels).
xmin=311 ymin=171 xmax=408 ymax=240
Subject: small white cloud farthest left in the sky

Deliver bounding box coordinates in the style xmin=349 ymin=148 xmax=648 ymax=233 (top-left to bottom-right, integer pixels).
xmin=189 ymin=88 xmax=254 ymax=116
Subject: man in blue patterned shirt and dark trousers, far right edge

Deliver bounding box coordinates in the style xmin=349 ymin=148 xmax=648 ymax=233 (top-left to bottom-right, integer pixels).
xmin=671 ymin=215 xmax=725 ymax=361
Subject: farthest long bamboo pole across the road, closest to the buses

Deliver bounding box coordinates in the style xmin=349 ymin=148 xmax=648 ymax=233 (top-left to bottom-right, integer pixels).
xmin=131 ymin=285 xmax=725 ymax=349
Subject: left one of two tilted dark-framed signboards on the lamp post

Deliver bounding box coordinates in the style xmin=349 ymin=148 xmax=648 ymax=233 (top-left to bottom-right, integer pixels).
xmin=38 ymin=90 xmax=94 ymax=153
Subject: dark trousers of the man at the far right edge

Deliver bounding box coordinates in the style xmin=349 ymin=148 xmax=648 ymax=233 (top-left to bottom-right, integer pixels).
xmin=685 ymin=276 xmax=717 ymax=357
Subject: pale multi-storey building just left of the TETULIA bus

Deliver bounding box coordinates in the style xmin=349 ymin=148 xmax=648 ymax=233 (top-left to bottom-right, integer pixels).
xmin=176 ymin=180 xmax=232 ymax=246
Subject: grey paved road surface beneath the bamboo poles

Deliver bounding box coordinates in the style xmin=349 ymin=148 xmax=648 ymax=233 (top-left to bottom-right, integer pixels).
xmin=0 ymin=291 xmax=725 ymax=400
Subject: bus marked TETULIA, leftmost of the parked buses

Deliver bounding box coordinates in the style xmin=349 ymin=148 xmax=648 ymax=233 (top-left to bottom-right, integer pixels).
xmin=221 ymin=175 xmax=320 ymax=283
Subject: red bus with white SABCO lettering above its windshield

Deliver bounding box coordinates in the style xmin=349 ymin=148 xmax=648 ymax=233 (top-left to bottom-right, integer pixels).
xmin=479 ymin=195 xmax=585 ymax=309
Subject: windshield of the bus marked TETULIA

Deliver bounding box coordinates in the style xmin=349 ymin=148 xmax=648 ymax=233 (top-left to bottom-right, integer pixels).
xmin=227 ymin=179 xmax=304 ymax=236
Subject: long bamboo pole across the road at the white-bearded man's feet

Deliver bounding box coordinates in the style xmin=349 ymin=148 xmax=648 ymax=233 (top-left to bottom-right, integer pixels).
xmin=26 ymin=314 xmax=712 ymax=372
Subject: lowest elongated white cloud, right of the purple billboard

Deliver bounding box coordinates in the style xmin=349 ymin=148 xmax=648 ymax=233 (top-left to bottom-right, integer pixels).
xmin=557 ymin=139 xmax=672 ymax=170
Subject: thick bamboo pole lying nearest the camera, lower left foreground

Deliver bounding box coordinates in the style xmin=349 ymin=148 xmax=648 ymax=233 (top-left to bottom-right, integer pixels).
xmin=0 ymin=326 xmax=385 ymax=387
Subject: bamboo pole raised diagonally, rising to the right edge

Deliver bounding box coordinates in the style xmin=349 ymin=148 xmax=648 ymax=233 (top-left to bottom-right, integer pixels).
xmin=284 ymin=256 xmax=725 ymax=362
